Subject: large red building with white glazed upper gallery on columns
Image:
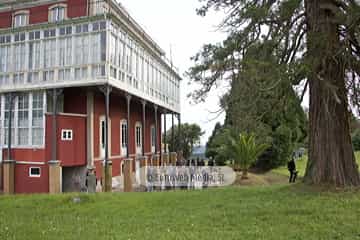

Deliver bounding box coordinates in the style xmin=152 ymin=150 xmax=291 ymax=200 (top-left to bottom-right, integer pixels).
xmin=0 ymin=0 xmax=181 ymax=193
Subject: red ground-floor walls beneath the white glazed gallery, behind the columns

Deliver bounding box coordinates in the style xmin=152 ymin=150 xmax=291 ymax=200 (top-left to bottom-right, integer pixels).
xmin=3 ymin=85 xmax=167 ymax=193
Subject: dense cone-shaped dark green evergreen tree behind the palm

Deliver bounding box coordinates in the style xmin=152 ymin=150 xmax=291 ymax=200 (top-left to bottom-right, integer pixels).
xmin=222 ymin=43 xmax=307 ymax=170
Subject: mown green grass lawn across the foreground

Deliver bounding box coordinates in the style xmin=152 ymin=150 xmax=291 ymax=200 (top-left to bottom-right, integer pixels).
xmin=0 ymin=184 xmax=360 ymax=240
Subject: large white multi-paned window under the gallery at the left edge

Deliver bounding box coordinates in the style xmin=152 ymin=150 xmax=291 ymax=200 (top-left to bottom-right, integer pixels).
xmin=0 ymin=91 xmax=46 ymax=147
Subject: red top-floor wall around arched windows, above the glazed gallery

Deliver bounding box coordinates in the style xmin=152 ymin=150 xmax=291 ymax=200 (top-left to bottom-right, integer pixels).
xmin=0 ymin=0 xmax=88 ymax=28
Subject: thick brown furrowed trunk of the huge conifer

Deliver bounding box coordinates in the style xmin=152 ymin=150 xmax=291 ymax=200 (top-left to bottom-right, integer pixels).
xmin=304 ymin=0 xmax=360 ymax=187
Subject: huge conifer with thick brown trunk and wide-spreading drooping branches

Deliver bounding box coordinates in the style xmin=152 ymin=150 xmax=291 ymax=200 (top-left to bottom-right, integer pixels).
xmin=189 ymin=0 xmax=360 ymax=186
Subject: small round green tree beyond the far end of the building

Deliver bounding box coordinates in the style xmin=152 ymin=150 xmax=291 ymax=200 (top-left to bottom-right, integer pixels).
xmin=166 ymin=123 xmax=204 ymax=159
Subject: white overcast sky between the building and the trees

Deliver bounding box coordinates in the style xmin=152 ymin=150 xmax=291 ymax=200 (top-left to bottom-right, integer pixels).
xmin=119 ymin=0 xmax=225 ymax=144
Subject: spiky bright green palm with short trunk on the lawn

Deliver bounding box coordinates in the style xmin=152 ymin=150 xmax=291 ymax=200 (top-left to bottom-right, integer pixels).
xmin=220 ymin=131 xmax=269 ymax=179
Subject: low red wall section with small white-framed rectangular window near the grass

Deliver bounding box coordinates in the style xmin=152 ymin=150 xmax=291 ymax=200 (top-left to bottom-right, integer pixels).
xmin=15 ymin=164 xmax=49 ymax=193
